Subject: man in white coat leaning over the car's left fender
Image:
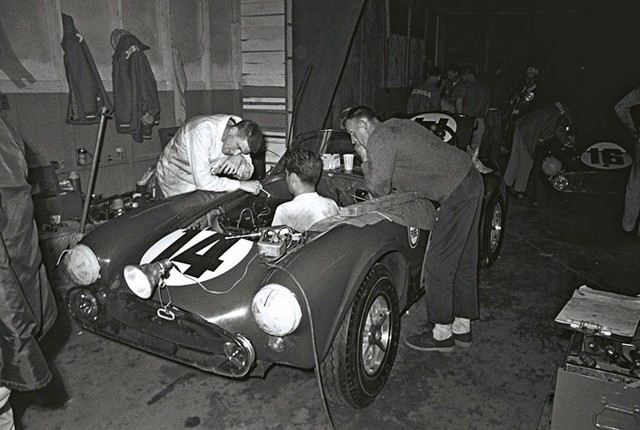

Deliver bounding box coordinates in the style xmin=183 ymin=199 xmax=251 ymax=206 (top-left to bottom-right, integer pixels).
xmin=156 ymin=115 xmax=263 ymax=197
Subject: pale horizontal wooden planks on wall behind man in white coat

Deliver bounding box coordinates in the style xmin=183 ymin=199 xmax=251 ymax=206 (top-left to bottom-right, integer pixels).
xmin=241 ymin=0 xmax=287 ymax=171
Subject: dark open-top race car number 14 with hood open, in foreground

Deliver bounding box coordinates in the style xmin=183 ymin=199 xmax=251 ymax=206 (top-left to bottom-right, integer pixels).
xmin=63 ymin=119 xmax=505 ymax=408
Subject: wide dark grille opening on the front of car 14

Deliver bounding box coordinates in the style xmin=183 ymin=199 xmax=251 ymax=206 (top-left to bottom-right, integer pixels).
xmin=67 ymin=287 xmax=255 ymax=378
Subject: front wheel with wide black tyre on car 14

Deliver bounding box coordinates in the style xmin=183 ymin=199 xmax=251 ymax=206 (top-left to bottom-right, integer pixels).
xmin=320 ymin=264 xmax=400 ymax=408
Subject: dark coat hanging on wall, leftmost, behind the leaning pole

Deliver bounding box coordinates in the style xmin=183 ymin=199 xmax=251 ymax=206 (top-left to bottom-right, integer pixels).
xmin=62 ymin=14 xmax=113 ymax=124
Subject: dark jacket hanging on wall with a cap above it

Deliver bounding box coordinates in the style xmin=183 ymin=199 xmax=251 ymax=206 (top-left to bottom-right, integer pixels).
xmin=111 ymin=29 xmax=160 ymax=142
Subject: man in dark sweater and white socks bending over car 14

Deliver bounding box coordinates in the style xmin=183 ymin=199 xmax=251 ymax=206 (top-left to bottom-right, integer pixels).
xmin=342 ymin=106 xmax=484 ymax=352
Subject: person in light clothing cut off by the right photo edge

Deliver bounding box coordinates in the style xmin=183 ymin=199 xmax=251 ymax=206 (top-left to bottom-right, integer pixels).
xmin=614 ymin=87 xmax=640 ymax=235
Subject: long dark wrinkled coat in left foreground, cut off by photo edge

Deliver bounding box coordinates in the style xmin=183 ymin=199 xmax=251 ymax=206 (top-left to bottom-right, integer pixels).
xmin=0 ymin=115 xmax=57 ymax=428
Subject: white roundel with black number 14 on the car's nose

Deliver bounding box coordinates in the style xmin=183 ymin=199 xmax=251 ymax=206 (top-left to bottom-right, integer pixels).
xmin=140 ymin=230 xmax=253 ymax=286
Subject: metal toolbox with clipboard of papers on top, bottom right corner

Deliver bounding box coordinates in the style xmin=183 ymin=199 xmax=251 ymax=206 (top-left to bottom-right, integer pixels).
xmin=551 ymin=285 xmax=640 ymax=430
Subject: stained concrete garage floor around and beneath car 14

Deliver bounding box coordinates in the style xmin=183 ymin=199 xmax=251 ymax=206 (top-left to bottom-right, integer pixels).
xmin=11 ymin=189 xmax=640 ymax=430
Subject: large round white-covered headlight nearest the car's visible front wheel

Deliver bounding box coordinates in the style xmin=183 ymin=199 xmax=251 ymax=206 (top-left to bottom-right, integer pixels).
xmin=251 ymin=284 xmax=302 ymax=336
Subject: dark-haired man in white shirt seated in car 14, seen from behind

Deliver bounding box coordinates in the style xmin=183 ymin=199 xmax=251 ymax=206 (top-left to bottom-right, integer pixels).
xmin=271 ymin=149 xmax=338 ymax=231
